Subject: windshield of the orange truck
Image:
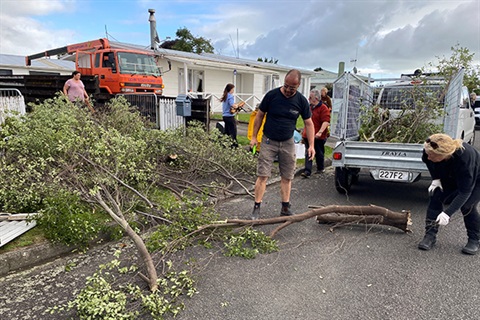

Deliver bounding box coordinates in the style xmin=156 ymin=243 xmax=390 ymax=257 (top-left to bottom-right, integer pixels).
xmin=118 ymin=52 xmax=161 ymax=77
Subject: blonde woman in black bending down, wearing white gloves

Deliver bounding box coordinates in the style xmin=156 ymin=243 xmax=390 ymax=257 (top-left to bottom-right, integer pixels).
xmin=418 ymin=133 xmax=480 ymax=254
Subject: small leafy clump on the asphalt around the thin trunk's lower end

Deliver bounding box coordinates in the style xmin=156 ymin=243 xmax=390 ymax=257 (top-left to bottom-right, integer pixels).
xmin=46 ymin=251 xmax=197 ymax=319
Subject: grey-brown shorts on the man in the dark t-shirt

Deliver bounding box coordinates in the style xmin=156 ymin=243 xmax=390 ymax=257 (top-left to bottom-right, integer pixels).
xmin=257 ymin=135 xmax=297 ymax=180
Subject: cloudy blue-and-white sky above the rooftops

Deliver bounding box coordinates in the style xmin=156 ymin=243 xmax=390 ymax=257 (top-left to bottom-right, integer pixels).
xmin=0 ymin=0 xmax=480 ymax=75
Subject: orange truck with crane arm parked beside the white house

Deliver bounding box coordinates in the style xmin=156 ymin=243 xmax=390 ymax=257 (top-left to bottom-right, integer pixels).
xmin=25 ymin=38 xmax=164 ymax=100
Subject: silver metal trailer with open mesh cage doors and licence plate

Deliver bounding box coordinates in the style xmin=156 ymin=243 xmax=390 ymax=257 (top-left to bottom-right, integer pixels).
xmin=331 ymin=69 xmax=475 ymax=194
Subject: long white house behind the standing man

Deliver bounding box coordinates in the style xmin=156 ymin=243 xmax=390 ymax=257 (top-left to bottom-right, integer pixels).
xmin=154 ymin=49 xmax=315 ymax=112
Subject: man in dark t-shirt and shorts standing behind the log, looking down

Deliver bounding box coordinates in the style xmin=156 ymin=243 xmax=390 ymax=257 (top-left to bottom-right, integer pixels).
xmin=250 ymin=69 xmax=315 ymax=220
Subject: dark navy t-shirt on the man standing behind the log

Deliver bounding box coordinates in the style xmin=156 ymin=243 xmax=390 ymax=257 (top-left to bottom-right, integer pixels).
xmin=260 ymin=88 xmax=312 ymax=141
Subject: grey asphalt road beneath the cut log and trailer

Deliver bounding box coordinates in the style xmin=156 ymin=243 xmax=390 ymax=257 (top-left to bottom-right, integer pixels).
xmin=0 ymin=132 xmax=480 ymax=320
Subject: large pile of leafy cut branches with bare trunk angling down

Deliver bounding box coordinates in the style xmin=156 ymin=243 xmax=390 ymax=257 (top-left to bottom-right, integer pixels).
xmin=0 ymin=95 xmax=255 ymax=291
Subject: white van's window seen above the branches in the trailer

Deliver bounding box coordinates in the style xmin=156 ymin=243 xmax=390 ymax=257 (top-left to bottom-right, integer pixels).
xmin=378 ymin=85 xmax=443 ymax=110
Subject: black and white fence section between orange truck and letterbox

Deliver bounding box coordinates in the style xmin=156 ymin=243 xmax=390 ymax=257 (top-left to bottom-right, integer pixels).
xmin=117 ymin=94 xmax=185 ymax=130
